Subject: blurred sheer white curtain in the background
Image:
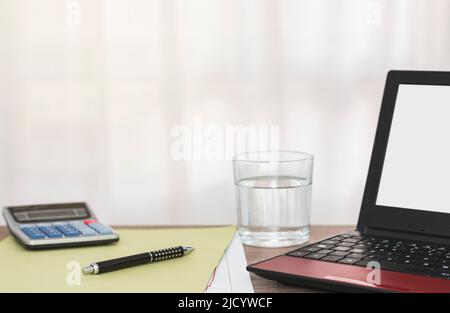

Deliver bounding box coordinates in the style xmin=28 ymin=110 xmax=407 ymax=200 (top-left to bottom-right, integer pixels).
xmin=0 ymin=0 xmax=450 ymax=224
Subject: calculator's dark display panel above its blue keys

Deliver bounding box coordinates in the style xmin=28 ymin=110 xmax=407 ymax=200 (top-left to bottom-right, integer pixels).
xmin=11 ymin=206 xmax=90 ymax=223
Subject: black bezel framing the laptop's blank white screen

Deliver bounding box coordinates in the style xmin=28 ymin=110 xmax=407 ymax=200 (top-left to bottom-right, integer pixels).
xmin=357 ymin=71 xmax=450 ymax=237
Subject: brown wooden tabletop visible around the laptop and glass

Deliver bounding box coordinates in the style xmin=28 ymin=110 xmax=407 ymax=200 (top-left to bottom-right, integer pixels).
xmin=0 ymin=226 xmax=354 ymax=293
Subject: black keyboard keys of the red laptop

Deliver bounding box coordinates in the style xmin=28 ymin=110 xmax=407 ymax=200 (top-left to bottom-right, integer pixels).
xmin=288 ymin=234 xmax=450 ymax=279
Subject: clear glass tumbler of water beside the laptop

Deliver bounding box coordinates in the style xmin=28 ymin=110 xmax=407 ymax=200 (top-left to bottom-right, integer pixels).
xmin=233 ymin=151 xmax=314 ymax=248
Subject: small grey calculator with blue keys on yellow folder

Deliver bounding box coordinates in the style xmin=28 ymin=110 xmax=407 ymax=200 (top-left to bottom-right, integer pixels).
xmin=3 ymin=202 xmax=119 ymax=250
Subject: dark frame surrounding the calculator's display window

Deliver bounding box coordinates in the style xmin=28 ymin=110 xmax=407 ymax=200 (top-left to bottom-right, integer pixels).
xmin=7 ymin=202 xmax=92 ymax=224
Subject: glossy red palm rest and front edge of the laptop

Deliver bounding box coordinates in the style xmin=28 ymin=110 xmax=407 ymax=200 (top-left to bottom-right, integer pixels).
xmin=247 ymin=255 xmax=450 ymax=293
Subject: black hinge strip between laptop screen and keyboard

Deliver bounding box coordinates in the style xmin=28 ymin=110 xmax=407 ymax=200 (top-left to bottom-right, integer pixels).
xmin=359 ymin=227 xmax=450 ymax=245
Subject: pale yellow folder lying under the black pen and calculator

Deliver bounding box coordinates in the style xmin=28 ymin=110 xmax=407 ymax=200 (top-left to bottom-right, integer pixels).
xmin=0 ymin=226 xmax=236 ymax=292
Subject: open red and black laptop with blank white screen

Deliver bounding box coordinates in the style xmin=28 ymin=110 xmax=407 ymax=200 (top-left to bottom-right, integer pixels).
xmin=247 ymin=71 xmax=450 ymax=293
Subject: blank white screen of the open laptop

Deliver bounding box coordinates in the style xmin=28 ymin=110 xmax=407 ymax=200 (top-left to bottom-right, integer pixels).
xmin=376 ymin=84 xmax=450 ymax=213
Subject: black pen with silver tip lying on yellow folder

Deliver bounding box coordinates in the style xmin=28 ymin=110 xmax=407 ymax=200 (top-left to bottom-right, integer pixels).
xmin=83 ymin=246 xmax=194 ymax=275
